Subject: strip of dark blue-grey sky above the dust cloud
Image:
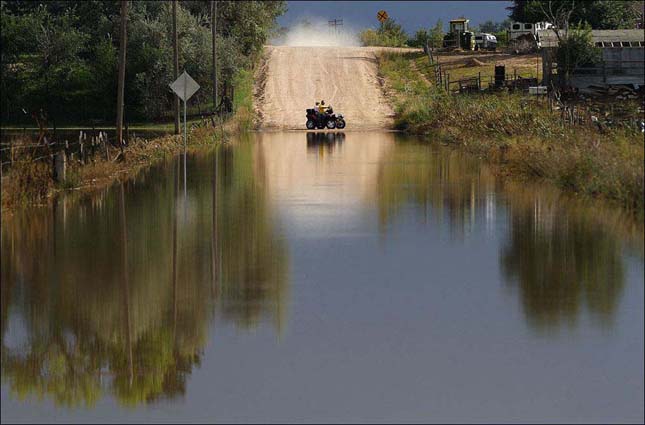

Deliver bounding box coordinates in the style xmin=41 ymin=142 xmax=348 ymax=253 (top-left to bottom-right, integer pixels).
xmin=278 ymin=1 xmax=511 ymax=33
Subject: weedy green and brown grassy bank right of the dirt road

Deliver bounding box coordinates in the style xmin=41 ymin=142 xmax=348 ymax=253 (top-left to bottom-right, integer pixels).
xmin=379 ymin=53 xmax=644 ymax=214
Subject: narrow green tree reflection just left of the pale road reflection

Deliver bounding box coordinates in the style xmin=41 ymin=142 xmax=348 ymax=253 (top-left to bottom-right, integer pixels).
xmin=217 ymin=143 xmax=287 ymax=327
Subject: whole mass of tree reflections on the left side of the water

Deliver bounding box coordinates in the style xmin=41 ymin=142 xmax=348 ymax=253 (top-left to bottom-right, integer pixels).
xmin=1 ymin=142 xmax=286 ymax=405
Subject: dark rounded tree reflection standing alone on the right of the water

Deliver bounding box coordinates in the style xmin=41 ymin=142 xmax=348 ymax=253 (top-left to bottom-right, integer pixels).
xmin=501 ymin=190 xmax=628 ymax=329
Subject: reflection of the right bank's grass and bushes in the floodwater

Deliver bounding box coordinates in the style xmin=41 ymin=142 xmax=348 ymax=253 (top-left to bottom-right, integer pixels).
xmin=376 ymin=136 xmax=643 ymax=330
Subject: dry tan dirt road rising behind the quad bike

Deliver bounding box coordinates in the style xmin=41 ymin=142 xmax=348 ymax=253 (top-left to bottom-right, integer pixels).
xmin=255 ymin=46 xmax=394 ymax=131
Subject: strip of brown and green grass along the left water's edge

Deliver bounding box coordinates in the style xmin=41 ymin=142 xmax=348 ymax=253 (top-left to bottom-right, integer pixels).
xmin=2 ymin=70 xmax=253 ymax=214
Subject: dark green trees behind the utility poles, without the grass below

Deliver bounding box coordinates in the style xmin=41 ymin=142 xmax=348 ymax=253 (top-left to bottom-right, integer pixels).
xmin=0 ymin=0 xmax=285 ymax=126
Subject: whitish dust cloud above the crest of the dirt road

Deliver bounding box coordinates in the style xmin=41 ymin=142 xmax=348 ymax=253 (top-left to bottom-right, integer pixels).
xmin=272 ymin=20 xmax=361 ymax=47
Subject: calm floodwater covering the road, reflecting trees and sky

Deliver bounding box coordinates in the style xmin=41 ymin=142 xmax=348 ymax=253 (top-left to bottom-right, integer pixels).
xmin=1 ymin=132 xmax=644 ymax=423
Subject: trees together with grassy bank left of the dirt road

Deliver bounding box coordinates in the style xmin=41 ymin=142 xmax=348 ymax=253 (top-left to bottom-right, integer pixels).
xmin=0 ymin=0 xmax=286 ymax=213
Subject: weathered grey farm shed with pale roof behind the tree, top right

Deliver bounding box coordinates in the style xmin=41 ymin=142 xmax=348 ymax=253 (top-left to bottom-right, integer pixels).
xmin=538 ymin=29 xmax=645 ymax=88
